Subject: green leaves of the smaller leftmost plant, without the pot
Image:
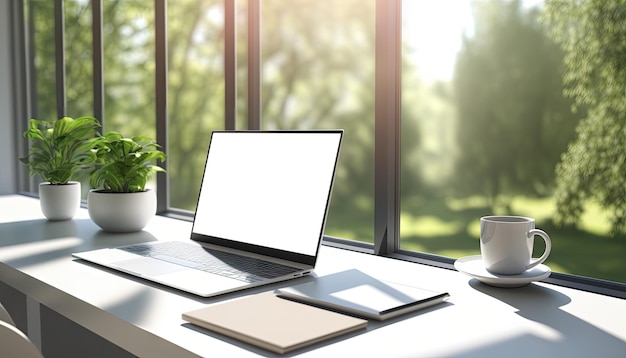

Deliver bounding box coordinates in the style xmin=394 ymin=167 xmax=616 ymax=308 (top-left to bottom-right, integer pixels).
xmin=20 ymin=117 xmax=100 ymax=184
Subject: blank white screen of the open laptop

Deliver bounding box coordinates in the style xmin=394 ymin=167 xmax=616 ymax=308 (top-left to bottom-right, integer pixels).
xmin=193 ymin=131 xmax=341 ymax=256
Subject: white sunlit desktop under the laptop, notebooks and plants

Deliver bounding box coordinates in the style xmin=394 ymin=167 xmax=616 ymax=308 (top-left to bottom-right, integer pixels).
xmin=0 ymin=195 xmax=626 ymax=358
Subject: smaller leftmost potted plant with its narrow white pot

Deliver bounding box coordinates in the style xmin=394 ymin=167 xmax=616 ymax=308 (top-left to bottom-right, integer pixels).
xmin=20 ymin=117 xmax=100 ymax=220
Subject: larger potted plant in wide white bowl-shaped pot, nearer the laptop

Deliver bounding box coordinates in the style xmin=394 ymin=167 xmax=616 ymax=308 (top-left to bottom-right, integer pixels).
xmin=87 ymin=132 xmax=166 ymax=232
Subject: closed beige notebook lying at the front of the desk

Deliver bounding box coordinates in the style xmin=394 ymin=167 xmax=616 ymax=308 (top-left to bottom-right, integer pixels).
xmin=183 ymin=292 xmax=367 ymax=354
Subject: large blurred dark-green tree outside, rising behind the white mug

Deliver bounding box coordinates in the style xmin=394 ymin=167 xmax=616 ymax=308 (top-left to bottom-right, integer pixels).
xmin=454 ymin=1 xmax=577 ymax=207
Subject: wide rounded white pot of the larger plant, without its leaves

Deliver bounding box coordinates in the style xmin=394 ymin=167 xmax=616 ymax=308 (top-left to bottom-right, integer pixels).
xmin=87 ymin=189 xmax=156 ymax=232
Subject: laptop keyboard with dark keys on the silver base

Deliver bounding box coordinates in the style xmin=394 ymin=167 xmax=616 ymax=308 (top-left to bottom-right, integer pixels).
xmin=119 ymin=241 xmax=300 ymax=282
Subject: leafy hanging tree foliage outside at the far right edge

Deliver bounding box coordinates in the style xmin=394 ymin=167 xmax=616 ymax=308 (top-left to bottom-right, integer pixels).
xmin=543 ymin=0 xmax=626 ymax=234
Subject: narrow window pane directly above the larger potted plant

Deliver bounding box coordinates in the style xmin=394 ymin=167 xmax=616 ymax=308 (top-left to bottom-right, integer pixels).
xmin=103 ymin=0 xmax=156 ymax=138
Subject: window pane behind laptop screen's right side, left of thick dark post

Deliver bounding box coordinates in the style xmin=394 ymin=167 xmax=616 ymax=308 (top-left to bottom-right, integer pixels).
xmin=261 ymin=0 xmax=375 ymax=242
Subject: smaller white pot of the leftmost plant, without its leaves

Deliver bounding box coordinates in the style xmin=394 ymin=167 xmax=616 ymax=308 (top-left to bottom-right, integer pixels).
xmin=39 ymin=181 xmax=80 ymax=220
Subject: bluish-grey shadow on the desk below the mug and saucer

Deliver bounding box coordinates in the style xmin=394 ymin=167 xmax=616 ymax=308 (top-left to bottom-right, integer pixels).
xmin=459 ymin=280 xmax=626 ymax=357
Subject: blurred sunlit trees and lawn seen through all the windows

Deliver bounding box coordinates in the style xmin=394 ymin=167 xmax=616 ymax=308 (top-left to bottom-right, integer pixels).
xmin=25 ymin=0 xmax=626 ymax=283
